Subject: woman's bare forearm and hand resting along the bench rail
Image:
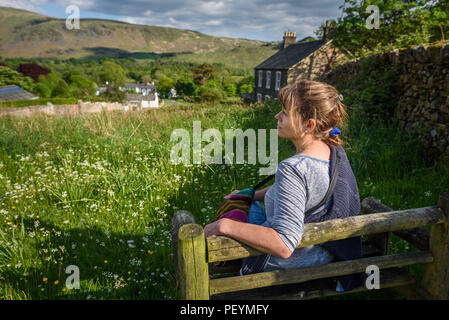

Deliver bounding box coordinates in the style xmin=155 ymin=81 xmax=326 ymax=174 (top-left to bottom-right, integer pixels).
xmin=204 ymin=218 xmax=292 ymax=259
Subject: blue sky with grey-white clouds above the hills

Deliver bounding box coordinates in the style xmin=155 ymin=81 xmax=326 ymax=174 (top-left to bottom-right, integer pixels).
xmin=0 ymin=0 xmax=344 ymax=41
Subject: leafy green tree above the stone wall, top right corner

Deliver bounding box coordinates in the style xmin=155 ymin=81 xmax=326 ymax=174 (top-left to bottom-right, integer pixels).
xmin=329 ymin=0 xmax=449 ymax=57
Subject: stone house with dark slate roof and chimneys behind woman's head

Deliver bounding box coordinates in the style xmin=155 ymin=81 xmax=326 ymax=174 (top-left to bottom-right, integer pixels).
xmin=253 ymin=21 xmax=345 ymax=102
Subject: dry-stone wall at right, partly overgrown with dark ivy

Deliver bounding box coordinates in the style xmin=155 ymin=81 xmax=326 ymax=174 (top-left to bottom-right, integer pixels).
xmin=321 ymin=43 xmax=449 ymax=165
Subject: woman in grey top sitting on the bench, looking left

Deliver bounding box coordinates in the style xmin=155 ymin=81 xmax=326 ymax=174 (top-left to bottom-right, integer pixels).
xmin=204 ymin=80 xmax=361 ymax=288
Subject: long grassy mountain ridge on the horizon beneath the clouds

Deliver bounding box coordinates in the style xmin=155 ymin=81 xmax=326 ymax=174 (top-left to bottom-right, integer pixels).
xmin=0 ymin=7 xmax=279 ymax=69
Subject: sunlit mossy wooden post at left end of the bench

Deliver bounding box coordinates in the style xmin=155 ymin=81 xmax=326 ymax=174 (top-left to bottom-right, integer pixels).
xmin=178 ymin=224 xmax=209 ymax=300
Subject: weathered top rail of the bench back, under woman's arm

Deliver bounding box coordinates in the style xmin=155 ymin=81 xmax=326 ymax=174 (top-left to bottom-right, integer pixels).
xmin=207 ymin=206 xmax=445 ymax=262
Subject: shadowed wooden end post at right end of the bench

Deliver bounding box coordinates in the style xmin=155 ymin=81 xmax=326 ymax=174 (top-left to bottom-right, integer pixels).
xmin=421 ymin=192 xmax=449 ymax=300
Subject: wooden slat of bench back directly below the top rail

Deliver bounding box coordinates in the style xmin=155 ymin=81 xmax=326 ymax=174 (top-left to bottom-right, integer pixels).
xmin=210 ymin=252 xmax=433 ymax=295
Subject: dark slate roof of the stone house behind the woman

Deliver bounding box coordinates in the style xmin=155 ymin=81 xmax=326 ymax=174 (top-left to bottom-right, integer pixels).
xmin=255 ymin=40 xmax=326 ymax=69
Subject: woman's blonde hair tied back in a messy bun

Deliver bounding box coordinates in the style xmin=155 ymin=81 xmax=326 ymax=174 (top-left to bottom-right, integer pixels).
xmin=278 ymin=80 xmax=347 ymax=147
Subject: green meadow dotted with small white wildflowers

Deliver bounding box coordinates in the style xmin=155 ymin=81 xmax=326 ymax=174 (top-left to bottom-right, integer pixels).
xmin=0 ymin=102 xmax=449 ymax=300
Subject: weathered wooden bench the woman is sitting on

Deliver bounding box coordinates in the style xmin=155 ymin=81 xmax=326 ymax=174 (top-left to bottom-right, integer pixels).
xmin=172 ymin=193 xmax=449 ymax=300
